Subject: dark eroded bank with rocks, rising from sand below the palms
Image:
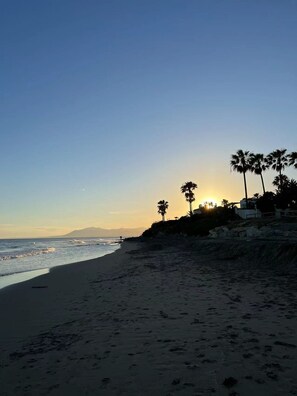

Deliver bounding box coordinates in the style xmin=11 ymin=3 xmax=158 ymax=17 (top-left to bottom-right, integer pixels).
xmin=143 ymin=219 xmax=297 ymax=275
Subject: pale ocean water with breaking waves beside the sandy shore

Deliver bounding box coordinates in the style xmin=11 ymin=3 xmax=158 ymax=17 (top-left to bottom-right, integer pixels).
xmin=0 ymin=238 xmax=120 ymax=289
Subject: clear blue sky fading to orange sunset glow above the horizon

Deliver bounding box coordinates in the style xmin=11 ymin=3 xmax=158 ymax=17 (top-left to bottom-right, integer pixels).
xmin=0 ymin=0 xmax=297 ymax=238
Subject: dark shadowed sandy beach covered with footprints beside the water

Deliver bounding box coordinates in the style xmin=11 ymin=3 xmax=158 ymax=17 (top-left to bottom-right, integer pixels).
xmin=0 ymin=237 xmax=297 ymax=396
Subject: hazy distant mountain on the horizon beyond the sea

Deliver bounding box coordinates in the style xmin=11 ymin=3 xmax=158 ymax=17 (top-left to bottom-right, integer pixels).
xmin=63 ymin=227 xmax=145 ymax=238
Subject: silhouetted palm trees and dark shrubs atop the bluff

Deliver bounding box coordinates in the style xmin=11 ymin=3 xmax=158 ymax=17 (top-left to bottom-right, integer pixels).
xmin=143 ymin=149 xmax=297 ymax=237
